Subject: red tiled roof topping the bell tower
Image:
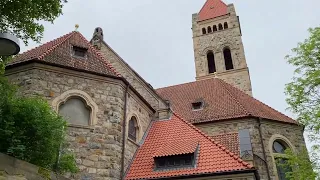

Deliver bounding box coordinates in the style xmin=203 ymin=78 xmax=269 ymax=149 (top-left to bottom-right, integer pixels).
xmin=199 ymin=0 xmax=228 ymax=21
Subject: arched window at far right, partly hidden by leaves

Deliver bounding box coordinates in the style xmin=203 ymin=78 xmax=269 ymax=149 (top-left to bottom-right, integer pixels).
xmin=272 ymin=140 xmax=292 ymax=180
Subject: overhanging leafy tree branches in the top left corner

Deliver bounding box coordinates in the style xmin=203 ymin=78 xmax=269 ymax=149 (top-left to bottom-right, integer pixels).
xmin=0 ymin=0 xmax=67 ymax=44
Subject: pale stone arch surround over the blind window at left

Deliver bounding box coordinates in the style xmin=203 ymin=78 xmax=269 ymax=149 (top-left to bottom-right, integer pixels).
xmin=51 ymin=90 xmax=98 ymax=126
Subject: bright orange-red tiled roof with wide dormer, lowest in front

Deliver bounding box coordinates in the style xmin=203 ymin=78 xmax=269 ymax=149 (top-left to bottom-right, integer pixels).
xmin=126 ymin=114 xmax=252 ymax=180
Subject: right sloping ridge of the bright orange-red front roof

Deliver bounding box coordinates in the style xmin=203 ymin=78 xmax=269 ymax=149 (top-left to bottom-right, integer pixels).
xmin=173 ymin=112 xmax=253 ymax=169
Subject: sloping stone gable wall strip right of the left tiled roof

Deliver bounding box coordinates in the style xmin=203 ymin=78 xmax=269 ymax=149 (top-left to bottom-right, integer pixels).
xmin=100 ymin=43 xmax=167 ymax=110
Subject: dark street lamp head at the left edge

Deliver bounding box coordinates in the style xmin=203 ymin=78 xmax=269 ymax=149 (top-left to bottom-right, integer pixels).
xmin=0 ymin=33 xmax=20 ymax=56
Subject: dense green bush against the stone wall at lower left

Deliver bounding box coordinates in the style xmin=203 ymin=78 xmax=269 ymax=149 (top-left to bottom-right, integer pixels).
xmin=0 ymin=76 xmax=76 ymax=172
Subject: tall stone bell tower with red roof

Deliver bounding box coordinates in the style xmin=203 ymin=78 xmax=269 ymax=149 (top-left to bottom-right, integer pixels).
xmin=192 ymin=0 xmax=252 ymax=95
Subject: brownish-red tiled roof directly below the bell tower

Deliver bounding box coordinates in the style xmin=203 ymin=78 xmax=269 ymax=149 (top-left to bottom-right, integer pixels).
xmin=157 ymin=78 xmax=297 ymax=124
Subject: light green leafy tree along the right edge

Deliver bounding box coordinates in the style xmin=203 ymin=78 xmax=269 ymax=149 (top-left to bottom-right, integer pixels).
xmin=285 ymin=27 xmax=320 ymax=179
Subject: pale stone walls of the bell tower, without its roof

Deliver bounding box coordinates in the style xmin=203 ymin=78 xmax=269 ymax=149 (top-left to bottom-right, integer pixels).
xmin=192 ymin=4 xmax=252 ymax=95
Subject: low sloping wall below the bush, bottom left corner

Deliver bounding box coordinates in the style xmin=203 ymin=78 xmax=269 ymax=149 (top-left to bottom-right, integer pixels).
xmin=0 ymin=153 xmax=67 ymax=180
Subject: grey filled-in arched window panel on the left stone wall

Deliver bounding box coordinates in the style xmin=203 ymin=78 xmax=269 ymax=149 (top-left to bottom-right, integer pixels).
xmin=59 ymin=97 xmax=91 ymax=126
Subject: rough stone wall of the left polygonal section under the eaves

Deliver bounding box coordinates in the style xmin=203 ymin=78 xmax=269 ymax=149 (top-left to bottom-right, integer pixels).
xmin=6 ymin=63 xmax=152 ymax=180
